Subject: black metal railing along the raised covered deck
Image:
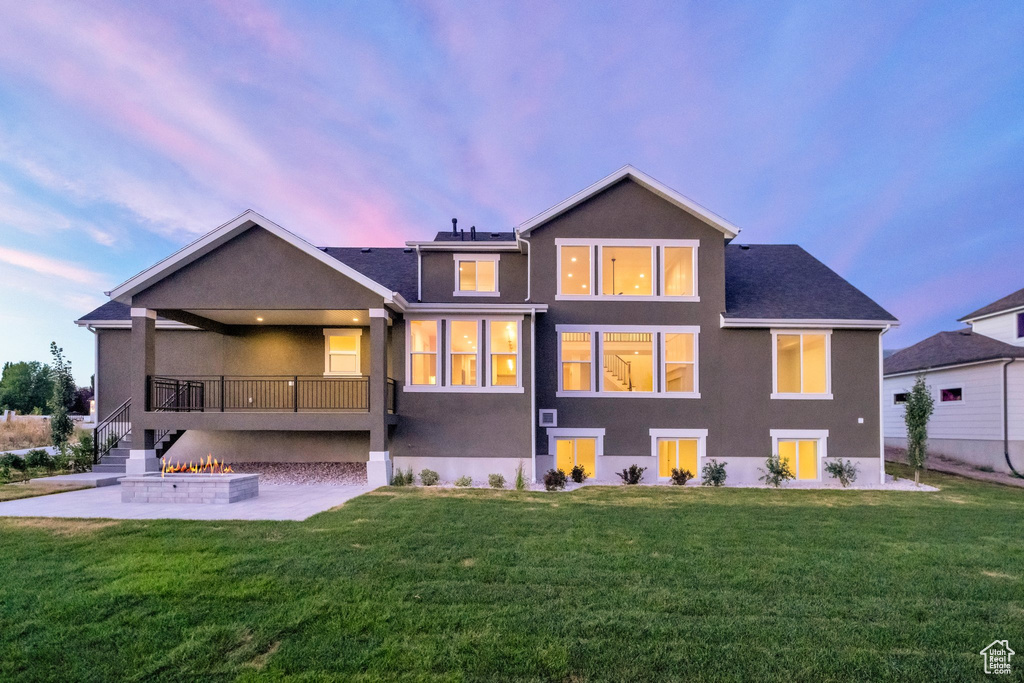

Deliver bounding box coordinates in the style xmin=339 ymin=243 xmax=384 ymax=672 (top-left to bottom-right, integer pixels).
xmin=150 ymin=375 xmax=397 ymax=413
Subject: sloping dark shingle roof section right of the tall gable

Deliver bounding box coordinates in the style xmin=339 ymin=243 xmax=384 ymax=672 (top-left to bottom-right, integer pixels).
xmin=725 ymin=245 xmax=896 ymax=323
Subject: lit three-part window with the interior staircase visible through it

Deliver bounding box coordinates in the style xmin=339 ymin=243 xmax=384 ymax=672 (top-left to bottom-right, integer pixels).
xmin=557 ymin=325 xmax=700 ymax=398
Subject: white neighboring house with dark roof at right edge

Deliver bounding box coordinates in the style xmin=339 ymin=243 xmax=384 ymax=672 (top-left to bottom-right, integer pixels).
xmin=885 ymin=289 xmax=1024 ymax=472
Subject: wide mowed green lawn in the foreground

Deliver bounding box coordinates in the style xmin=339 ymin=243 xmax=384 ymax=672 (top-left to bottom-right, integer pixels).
xmin=0 ymin=470 xmax=1024 ymax=681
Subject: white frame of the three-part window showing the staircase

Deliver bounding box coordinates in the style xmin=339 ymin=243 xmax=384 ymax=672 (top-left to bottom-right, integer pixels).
xmin=555 ymin=325 xmax=700 ymax=398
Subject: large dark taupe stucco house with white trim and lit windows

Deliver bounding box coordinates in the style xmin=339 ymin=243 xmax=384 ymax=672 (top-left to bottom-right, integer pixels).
xmin=78 ymin=166 xmax=896 ymax=484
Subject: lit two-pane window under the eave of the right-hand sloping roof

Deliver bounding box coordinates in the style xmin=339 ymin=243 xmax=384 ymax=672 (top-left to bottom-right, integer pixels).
xmin=772 ymin=331 xmax=831 ymax=398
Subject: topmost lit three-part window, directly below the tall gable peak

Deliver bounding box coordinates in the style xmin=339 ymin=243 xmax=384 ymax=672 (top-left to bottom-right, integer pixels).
xmin=555 ymin=239 xmax=698 ymax=301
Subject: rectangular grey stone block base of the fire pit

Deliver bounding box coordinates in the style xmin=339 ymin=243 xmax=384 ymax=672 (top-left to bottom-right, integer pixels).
xmin=121 ymin=472 xmax=259 ymax=504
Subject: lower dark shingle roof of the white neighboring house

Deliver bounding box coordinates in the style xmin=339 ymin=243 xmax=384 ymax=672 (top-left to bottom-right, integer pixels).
xmin=884 ymin=329 xmax=1024 ymax=375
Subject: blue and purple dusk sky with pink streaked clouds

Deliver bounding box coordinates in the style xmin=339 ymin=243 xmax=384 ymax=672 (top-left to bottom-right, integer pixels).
xmin=0 ymin=0 xmax=1024 ymax=383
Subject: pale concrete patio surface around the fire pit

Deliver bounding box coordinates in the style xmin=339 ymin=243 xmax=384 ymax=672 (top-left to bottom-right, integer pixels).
xmin=0 ymin=484 xmax=373 ymax=521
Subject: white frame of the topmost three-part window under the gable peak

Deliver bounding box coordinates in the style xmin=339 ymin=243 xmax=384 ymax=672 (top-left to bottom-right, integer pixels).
xmin=555 ymin=238 xmax=700 ymax=302
